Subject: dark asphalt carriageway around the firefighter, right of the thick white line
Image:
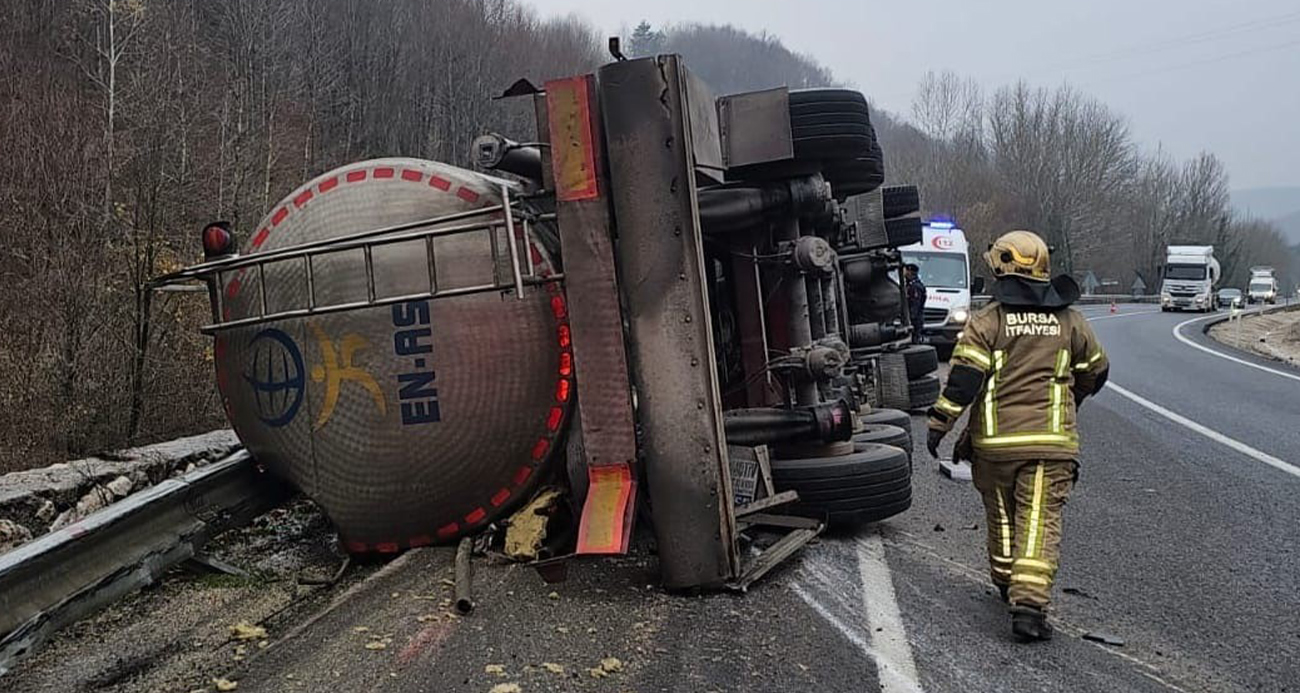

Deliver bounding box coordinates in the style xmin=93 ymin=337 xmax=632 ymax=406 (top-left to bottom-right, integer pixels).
xmin=863 ymin=306 xmax=1300 ymax=692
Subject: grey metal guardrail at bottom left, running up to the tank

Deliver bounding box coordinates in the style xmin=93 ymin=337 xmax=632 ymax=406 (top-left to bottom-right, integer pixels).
xmin=0 ymin=450 xmax=289 ymax=676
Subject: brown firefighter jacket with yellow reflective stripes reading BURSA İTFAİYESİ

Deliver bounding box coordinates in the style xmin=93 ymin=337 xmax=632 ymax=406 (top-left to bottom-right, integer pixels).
xmin=930 ymin=302 xmax=1110 ymax=460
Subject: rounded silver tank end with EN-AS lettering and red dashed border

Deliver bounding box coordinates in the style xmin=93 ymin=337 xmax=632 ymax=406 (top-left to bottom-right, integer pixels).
xmin=216 ymin=159 xmax=573 ymax=553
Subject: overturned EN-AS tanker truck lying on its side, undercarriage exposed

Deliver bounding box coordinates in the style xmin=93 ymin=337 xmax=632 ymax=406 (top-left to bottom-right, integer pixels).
xmin=155 ymin=56 xmax=937 ymax=588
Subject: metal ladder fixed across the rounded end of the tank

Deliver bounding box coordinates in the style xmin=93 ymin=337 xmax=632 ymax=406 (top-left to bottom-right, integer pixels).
xmin=150 ymin=185 xmax=563 ymax=334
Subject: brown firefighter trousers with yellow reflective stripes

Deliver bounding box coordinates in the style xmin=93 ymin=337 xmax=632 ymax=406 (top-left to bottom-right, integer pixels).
xmin=971 ymin=456 xmax=1078 ymax=608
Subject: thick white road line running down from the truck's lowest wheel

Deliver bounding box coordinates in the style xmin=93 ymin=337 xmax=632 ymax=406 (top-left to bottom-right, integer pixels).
xmin=858 ymin=532 xmax=920 ymax=692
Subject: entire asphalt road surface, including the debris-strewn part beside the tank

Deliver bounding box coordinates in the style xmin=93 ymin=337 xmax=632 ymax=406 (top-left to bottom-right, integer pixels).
xmin=4 ymin=306 xmax=1300 ymax=693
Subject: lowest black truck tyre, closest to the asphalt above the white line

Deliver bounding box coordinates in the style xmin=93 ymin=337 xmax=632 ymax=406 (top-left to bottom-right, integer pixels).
xmin=772 ymin=443 xmax=911 ymax=525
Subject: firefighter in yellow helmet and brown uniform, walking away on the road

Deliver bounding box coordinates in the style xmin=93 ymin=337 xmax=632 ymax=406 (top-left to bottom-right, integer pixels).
xmin=927 ymin=231 xmax=1109 ymax=642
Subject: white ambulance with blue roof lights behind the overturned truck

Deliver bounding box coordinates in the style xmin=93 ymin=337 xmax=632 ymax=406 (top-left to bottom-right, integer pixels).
xmin=898 ymin=218 xmax=971 ymax=351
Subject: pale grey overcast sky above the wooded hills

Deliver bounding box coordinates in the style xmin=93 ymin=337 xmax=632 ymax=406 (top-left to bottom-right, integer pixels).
xmin=524 ymin=0 xmax=1300 ymax=189
